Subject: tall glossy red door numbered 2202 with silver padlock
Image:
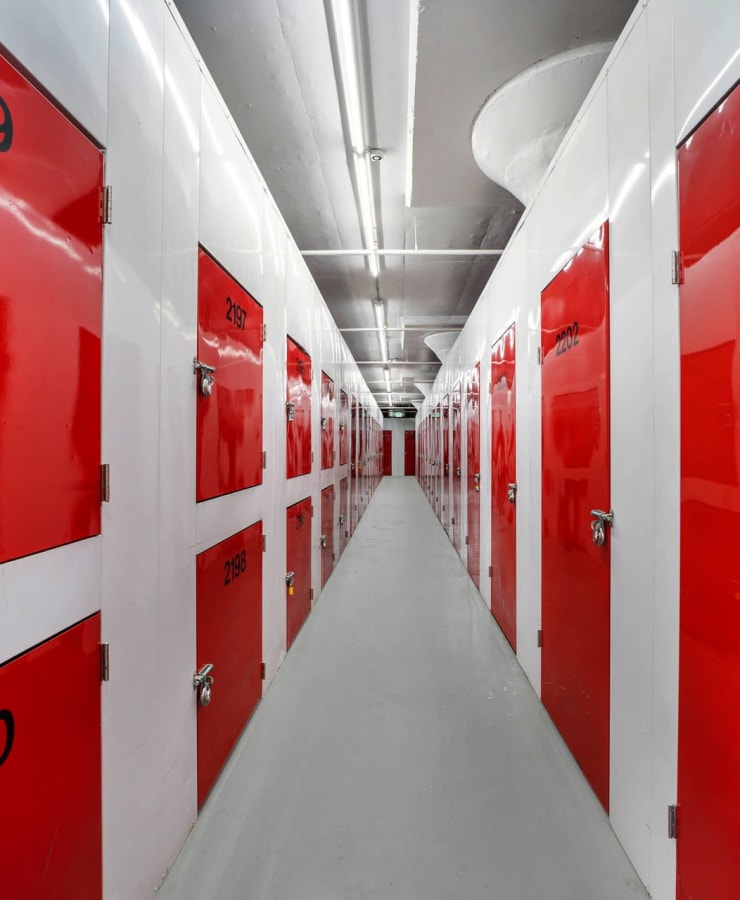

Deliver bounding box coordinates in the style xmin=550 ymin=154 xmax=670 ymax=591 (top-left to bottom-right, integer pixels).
xmin=542 ymin=223 xmax=612 ymax=809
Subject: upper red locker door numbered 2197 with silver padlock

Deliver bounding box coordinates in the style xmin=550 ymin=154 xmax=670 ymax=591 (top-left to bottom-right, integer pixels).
xmin=196 ymin=247 xmax=263 ymax=501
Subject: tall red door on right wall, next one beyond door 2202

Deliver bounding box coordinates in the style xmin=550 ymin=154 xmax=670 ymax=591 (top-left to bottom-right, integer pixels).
xmin=491 ymin=325 xmax=518 ymax=650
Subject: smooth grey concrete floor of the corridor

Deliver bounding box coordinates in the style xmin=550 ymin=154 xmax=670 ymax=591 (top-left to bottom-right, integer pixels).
xmin=158 ymin=478 xmax=648 ymax=900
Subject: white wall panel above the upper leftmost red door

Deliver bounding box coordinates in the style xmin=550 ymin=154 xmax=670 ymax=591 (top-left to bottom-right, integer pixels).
xmin=0 ymin=0 xmax=109 ymax=147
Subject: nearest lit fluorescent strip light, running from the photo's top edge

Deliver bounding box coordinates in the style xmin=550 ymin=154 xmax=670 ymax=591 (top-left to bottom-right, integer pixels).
xmin=331 ymin=0 xmax=382 ymax=278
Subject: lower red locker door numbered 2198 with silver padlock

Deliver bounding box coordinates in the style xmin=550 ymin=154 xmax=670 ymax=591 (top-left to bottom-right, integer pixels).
xmin=195 ymin=522 xmax=262 ymax=807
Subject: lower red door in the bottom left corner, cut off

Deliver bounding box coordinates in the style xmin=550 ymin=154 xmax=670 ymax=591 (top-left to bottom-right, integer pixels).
xmin=0 ymin=614 xmax=102 ymax=900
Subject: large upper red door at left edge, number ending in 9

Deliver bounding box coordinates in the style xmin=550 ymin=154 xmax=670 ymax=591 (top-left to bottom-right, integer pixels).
xmin=0 ymin=56 xmax=103 ymax=562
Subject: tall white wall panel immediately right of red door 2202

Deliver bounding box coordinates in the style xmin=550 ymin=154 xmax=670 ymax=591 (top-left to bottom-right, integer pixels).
xmin=607 ymin=15 xmax=654 ymax=883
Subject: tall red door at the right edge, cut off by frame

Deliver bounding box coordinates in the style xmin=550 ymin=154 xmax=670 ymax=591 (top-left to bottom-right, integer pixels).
xmin=677 ymin=81 xmax=740 ymax=900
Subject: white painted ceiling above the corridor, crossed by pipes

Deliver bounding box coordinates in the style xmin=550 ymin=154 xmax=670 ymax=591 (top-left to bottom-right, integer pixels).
xmin=176 ymin=0 xmax=635 ymax=414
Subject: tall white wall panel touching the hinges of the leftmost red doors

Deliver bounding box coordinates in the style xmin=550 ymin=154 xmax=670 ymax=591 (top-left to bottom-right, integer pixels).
xmin=102 ymin=0 xmax=166 ymax=900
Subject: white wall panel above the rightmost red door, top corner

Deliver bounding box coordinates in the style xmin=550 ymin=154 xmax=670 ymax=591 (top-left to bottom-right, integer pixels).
xmin=666 ymin=0 xmax=740 ymax=143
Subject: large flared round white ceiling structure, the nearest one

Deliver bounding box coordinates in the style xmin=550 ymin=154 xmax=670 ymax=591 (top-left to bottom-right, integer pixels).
xmin=474 ymin=43 xmax=613 ymax=206
